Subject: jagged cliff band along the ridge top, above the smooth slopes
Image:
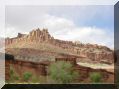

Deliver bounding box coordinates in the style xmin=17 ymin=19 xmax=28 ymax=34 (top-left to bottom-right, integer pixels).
xmin=5 ymin=28 xmax=114 ymax=63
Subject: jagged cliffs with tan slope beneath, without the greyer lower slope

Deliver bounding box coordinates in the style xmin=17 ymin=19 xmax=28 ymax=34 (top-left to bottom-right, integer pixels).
xmin=5 ymin=28 xmax=114 ymax=63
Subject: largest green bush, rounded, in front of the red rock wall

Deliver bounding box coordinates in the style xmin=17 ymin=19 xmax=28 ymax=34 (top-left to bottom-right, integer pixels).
xmin=49 ymin=61 xmax=79 ymax=84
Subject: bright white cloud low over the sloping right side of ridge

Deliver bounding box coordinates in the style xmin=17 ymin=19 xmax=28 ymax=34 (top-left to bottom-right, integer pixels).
xmin=57 ymin=27 xmax=114 ymax=48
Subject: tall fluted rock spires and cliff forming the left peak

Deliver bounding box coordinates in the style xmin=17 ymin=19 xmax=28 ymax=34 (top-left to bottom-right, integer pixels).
xmin=5 ymin=29 xmax=52 ymax=45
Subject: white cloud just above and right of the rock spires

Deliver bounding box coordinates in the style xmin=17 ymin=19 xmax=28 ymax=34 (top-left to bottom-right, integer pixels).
xmin=40 ymin=14 xmax=75 ymax=34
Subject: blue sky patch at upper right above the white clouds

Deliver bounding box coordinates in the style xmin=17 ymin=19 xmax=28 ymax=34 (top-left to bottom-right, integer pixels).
xmin=48 ymin=5 xmax=114 ymax=30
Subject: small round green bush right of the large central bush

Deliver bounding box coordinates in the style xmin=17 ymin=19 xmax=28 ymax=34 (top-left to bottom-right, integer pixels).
xmin=90 ymin=72 xmax=102 ymax=83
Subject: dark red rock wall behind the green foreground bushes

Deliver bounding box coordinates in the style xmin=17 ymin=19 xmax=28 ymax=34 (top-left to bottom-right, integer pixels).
xmin=5 ymin=58 xmax=114 ymax=83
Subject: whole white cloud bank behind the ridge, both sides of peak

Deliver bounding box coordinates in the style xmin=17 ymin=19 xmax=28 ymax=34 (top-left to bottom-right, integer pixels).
xmin=6 ymin=14 xmax=114 ymax=48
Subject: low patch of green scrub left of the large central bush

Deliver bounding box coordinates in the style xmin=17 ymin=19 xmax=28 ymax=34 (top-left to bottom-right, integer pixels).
xmin=6 ymin=65 xmax=46 ymax=83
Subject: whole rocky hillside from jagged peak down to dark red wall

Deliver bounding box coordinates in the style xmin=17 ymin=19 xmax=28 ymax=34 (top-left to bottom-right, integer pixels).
xmin=5 ymin=28 xmax=114 ymax=63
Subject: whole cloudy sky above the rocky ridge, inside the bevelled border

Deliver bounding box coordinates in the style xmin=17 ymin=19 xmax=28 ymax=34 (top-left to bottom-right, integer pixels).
xmin=5 ymin=5 xmax=114 ymax=48
